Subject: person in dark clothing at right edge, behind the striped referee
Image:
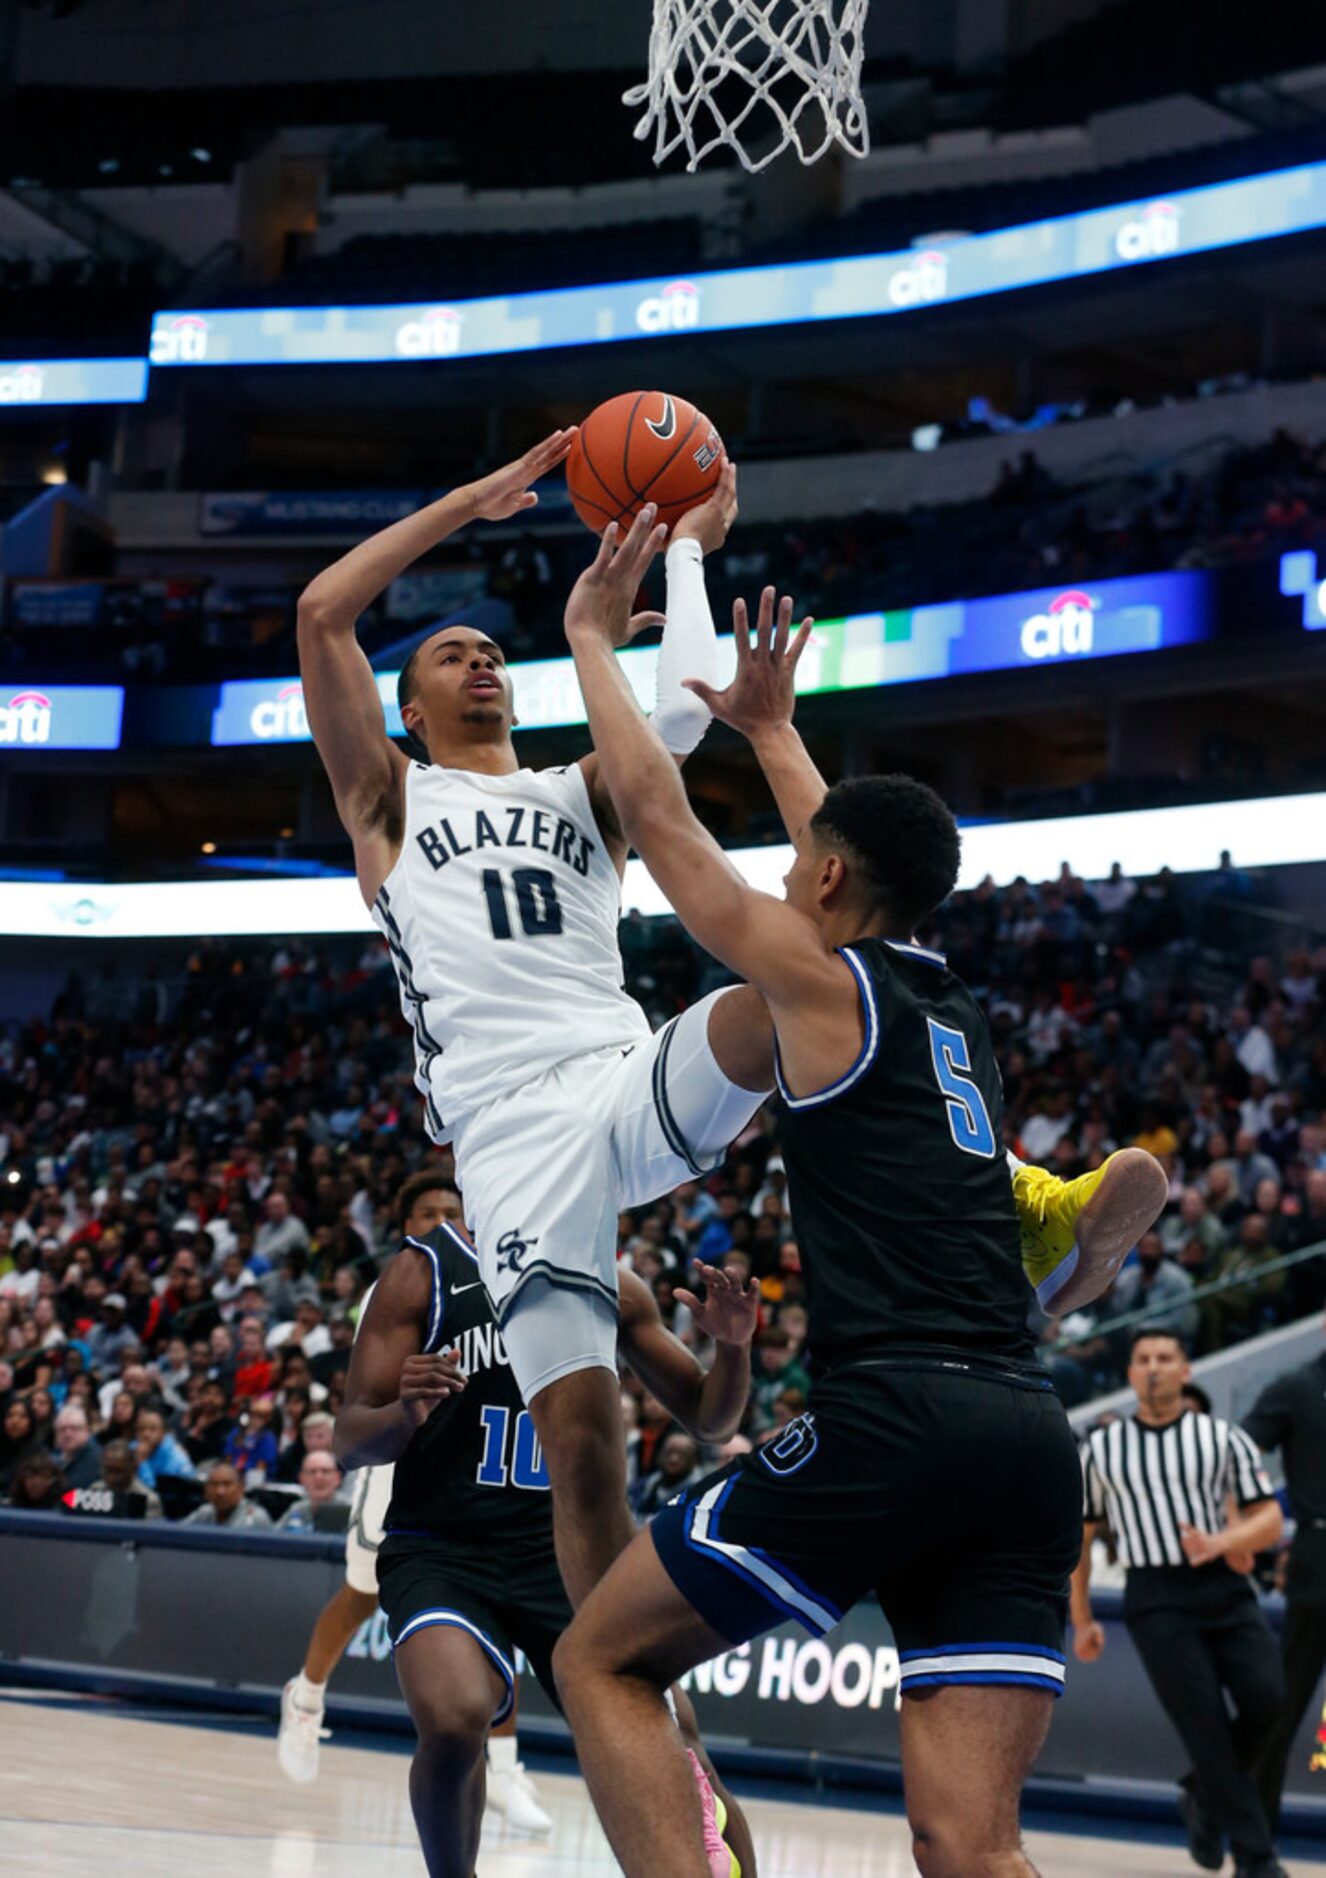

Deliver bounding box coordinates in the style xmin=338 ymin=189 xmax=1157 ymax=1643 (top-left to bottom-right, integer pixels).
xmin=1243 ymin=1314 xmax=1326 ymax=1831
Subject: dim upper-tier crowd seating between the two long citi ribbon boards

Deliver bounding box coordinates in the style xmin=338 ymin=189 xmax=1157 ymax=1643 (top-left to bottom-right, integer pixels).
xmin=4 ymin=430 xmax=1326 ymax=682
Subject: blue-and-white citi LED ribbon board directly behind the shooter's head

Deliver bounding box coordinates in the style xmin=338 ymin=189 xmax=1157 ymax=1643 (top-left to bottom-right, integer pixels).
xmin=212 ymin=573 xmax=1213 ymax=744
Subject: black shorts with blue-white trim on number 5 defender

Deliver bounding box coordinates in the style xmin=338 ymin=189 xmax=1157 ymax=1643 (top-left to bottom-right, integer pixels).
xmin=650 ymin=1358 xmax=1082 ymax=1696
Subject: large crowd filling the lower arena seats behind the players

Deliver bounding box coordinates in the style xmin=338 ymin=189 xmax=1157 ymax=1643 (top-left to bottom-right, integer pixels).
xmin=0 ymin=852 xmax=1326 ymax=1531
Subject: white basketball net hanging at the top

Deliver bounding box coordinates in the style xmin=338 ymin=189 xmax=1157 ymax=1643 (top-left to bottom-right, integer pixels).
xmin=624 ymin=0 xmax=870 ymax=171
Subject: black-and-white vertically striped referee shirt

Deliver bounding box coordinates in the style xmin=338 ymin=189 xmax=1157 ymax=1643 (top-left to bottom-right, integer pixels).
xmin=1082 ymin=1412 xmax=1273 ymax=1570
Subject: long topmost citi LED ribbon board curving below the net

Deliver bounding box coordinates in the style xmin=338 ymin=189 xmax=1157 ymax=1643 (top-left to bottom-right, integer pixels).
xmin=152 ymin=163 xmax=1326 ymax=368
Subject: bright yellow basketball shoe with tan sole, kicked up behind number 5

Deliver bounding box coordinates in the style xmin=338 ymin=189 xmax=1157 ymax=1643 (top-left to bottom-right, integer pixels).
xmin=1012 ymin=1147 xmax=1168 ymax=1316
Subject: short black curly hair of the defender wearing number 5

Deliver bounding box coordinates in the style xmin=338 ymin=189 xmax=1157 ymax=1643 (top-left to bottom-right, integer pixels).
xmin=811 ymin=776 xmax=962 ymax=937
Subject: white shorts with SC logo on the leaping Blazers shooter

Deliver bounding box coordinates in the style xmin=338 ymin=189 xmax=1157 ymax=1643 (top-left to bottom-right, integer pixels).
xmin=455 ymin=992 xmax=764 ymax=1401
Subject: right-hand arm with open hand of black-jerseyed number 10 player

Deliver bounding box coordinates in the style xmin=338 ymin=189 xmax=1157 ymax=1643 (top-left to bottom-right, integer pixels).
xmin=618 ymin=1266 xmax=759 ymax=1440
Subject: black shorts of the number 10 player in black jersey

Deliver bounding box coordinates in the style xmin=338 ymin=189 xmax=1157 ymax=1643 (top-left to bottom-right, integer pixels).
xmin=378 ymin=1532 xmax=571 ymax=1726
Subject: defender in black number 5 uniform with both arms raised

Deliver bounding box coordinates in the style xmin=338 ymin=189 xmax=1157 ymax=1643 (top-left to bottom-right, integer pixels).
xmin=558 ymin=509 xmax=1082 ymax=1878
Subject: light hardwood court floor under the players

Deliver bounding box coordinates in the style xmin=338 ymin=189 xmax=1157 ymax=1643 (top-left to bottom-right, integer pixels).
xmin=0 ymin=1690 xmax=1326 ymax=1878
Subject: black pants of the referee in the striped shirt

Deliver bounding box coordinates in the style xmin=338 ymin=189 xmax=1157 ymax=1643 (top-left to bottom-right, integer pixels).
xmin=1127 ymin=1581 xmax=1285 ymax=1865
